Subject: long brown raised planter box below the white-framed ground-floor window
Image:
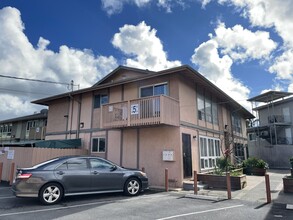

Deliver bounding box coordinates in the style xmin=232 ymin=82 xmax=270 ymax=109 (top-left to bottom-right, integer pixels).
xmin=197 ymin=173 xmax=247 ymax=190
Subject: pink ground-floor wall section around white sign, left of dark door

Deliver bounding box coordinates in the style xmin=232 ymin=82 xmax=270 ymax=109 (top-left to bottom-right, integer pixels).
xmin=137 ymin=126 xmax=183 ymax=187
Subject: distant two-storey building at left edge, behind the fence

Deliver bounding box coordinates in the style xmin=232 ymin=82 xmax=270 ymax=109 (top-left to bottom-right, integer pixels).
xmin=0 ymin=109 xmax=48 ymax=145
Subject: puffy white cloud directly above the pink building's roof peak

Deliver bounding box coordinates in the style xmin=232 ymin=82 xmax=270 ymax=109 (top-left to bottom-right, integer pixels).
xmin=112 ymin=21 xmax=181 ymax=70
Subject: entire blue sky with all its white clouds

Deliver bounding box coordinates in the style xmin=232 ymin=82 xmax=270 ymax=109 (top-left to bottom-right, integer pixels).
xmin=0 ymin=0 xmax=293 ymax=120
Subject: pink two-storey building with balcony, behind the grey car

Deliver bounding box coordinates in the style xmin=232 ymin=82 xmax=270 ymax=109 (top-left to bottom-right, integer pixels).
xmin=33 ymin=66 xmax=254 ymax=187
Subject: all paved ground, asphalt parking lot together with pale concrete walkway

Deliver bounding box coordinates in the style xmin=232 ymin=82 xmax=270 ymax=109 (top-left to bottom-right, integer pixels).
xmin=0 ymin=170 xmax=293 ymax=220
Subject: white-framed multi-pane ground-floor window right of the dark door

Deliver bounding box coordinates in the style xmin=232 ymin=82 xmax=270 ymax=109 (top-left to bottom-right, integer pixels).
xmin=199 ymin=137 xmax=221 ymax=169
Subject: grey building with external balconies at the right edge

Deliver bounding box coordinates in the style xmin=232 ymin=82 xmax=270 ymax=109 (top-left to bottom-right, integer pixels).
xmin=247 ymin=91 xmax=293 ymax=168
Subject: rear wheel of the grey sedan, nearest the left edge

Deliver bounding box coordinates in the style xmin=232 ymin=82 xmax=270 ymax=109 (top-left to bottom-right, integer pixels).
xmin=39 ymin=183 xmax=63 ymax=205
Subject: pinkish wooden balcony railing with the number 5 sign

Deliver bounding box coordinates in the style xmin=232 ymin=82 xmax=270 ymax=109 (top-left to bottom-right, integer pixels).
xmin=102 ymin=95 xmax=179 ymax=128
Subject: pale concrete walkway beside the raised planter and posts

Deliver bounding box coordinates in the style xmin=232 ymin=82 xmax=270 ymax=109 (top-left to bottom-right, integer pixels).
xmin=189 ymin=170 xmax=293 ymax=205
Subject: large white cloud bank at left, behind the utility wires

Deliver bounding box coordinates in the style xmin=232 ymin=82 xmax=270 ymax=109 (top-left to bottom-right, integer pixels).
xmin=0 ymin=7 xmax=117 ymax=120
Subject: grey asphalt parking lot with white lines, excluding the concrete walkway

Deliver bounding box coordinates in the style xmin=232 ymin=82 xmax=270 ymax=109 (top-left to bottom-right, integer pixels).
xmin=0 ymin=183 xmax=293 ymax=220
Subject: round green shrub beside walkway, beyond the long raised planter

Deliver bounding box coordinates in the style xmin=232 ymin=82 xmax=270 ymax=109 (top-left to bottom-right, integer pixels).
xmin=242 ymin=157 xmax=268 ymax=176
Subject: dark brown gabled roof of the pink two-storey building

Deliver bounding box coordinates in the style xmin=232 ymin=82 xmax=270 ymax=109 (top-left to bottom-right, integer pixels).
xmin=32 ymin=65 xmax=254 ymax=119
